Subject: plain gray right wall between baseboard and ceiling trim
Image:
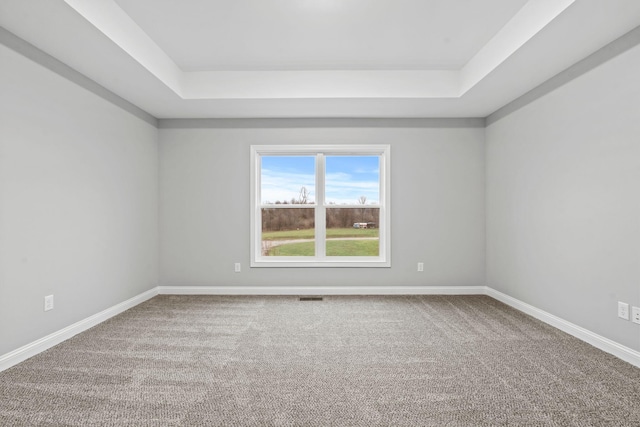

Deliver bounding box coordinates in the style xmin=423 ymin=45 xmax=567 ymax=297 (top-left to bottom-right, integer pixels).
xmin=486 ymin=43 xmax=640 ymax=350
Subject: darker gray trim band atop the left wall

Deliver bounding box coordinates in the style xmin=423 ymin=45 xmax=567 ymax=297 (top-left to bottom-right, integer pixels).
xmin=0 ymin=27 xmax=158 ymax=128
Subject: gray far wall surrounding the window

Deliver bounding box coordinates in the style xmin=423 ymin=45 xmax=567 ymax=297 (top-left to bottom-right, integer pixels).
xmin=160 ymin=120 xmax=485 ymax=286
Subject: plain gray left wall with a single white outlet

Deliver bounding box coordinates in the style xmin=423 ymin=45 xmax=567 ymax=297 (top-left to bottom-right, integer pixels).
xmin=0 ymin=45 xmax=158 ymax=355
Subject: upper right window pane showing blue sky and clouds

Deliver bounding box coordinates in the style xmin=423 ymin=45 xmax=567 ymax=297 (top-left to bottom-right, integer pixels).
xmin=325 ymin=156 xmax=380 ymax=205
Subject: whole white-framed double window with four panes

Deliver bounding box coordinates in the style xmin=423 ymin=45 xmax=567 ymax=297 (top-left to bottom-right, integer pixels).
xmin=251 ymin=145 xmax=390 ymax=267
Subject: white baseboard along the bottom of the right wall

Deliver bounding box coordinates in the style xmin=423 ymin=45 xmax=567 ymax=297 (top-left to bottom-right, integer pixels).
xmin=486 ymin=287 xmax=640 ymax=368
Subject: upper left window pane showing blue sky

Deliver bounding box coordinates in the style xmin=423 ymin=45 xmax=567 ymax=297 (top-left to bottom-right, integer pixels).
xmin=260 ymin=156 xmax=316 ymax=204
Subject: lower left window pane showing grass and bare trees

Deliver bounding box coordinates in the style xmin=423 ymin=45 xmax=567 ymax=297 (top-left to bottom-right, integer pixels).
xmin=261 ymin=208 xmax=316 ymax=256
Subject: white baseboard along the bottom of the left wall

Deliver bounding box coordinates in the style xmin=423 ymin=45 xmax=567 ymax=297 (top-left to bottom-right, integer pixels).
xmin=0 ymin=287 xmax=158 ymax=372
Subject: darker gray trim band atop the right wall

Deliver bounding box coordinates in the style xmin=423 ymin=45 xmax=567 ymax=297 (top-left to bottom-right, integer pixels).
xmin=486 ymin=26 xmax=640 ymax=126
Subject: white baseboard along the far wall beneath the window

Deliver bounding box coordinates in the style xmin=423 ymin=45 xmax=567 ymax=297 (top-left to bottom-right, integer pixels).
xmin=158 ymin=286 xmax=485 ymax=295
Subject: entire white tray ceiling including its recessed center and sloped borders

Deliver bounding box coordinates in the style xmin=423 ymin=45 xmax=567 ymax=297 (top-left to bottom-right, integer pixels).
xmin=0 ymin=0 xmax=640 ymax=118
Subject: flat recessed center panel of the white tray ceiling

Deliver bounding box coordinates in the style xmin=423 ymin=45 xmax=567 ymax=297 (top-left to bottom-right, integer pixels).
xmin=111 ymin=0 xmax=527 ymax=71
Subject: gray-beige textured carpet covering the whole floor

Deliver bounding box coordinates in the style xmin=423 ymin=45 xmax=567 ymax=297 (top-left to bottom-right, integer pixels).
xmin=0 ymin=296 xmax=640 ymax=427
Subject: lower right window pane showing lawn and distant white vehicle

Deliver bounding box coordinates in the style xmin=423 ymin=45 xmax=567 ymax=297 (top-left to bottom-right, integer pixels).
xmin=326 ymin=205 xmax=380 ymax=256
